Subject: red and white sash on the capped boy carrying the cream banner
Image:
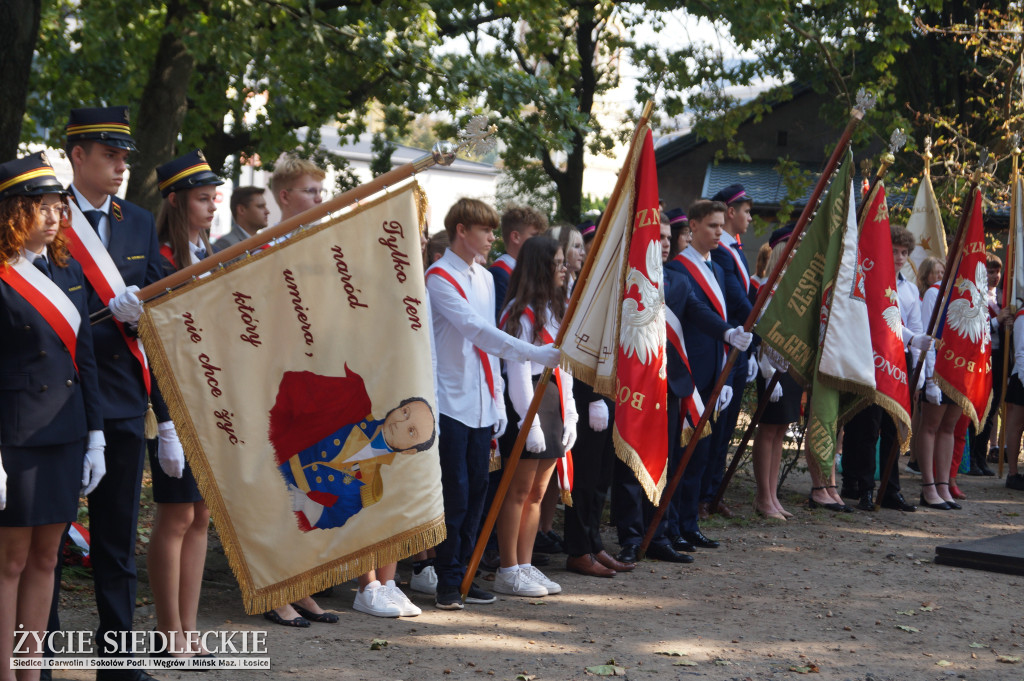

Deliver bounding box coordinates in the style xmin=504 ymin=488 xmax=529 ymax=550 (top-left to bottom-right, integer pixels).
xmin=65 ymin=201 xmax=152 ymax=394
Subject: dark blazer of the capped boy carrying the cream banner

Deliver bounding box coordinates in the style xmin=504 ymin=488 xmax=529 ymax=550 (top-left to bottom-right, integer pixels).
xmin=72 ymin=194 xmax=166 ymax=420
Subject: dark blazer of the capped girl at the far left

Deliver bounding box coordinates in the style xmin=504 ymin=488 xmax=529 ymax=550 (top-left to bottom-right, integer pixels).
xmin=0 ymin=259 xmax=103 ymax=446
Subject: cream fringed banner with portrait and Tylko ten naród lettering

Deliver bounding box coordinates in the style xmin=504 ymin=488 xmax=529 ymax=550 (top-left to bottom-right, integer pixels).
xmin=140 ymin=183 xmax=444 ymax=613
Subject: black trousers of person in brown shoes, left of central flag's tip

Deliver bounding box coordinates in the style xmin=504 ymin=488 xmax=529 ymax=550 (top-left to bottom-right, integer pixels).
xmin=565 ymin=399 xmax=616 ymax=556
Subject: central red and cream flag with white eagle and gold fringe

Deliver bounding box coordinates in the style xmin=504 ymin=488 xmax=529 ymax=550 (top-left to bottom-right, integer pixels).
xmin=561 ymin=126 xmax=669 ymax=504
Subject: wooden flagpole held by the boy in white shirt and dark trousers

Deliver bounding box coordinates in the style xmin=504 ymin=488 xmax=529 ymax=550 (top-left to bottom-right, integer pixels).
xmin=459 ymin=101 xmax=654 ymax=600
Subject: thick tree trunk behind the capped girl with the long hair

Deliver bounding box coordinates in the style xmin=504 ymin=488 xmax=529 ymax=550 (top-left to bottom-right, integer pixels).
xmin=127 ymin=1 xmax=196 ymax=214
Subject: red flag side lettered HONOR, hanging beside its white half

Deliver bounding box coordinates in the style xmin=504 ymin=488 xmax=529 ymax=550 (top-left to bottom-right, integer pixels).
xmin=857 ymin=182 xmax=910 ymax=445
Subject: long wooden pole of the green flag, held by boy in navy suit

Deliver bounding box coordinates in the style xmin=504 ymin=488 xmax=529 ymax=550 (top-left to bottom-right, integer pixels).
xmin=639 ymin=95 xmax=873 ymax=556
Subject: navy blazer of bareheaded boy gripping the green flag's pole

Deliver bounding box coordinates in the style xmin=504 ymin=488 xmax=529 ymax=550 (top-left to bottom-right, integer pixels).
xmin=663 ymin=267 xmax=732 ymax=397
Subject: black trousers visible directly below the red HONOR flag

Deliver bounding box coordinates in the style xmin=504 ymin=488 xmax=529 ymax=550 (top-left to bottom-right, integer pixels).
xmin=843 ymin=405 xmax=900 ymax=497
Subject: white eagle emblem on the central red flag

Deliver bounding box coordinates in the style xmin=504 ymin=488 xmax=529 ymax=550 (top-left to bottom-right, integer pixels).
xmin=618 ymin=241 xmax=666 ymax=365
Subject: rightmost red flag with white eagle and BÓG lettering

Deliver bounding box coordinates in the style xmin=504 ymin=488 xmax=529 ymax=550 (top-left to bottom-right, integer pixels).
xmin=935 ymin=189 xmax=992 ymax=428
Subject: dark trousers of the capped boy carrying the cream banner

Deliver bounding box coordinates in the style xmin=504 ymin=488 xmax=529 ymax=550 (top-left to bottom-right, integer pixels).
xmin=47 ymin=417 xmax=145 ymax=656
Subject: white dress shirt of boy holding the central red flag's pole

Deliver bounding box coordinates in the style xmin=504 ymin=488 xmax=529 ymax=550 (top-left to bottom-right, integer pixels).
xmin=427 ymin=249 xmax=534 ymax=428
